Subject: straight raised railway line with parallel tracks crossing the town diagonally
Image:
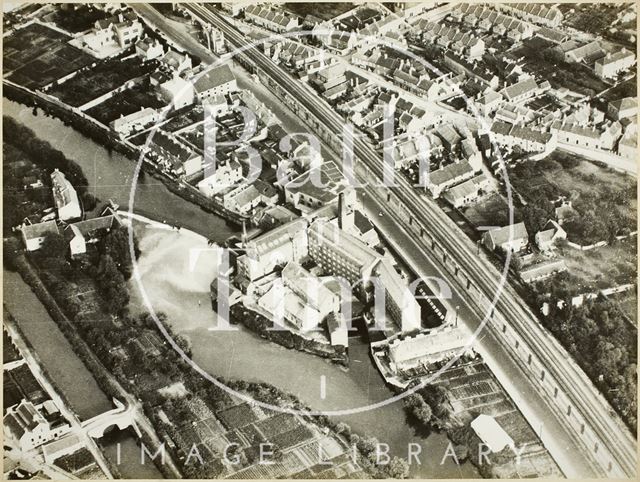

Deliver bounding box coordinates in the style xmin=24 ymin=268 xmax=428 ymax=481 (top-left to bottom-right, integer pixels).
xmin=182 ymin=3 xmax=637 ymax=477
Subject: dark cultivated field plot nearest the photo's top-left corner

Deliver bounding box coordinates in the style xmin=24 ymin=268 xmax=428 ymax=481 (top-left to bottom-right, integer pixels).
xmin=2 ymin=23 xmax=95 ymax=89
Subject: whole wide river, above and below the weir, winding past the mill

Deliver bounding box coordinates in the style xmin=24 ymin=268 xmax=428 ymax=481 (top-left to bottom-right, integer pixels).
xmin=3 ymin=99 xmax=479 ymax=478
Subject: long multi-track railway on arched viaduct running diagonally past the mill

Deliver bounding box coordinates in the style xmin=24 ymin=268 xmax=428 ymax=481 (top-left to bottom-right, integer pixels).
xmin=146 ymin=4 xmax=636 ymax=477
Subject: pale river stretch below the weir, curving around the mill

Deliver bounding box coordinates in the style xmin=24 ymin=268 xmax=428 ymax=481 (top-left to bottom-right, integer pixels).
xmin=130 ymin=226 xmax=479 ymax=478
